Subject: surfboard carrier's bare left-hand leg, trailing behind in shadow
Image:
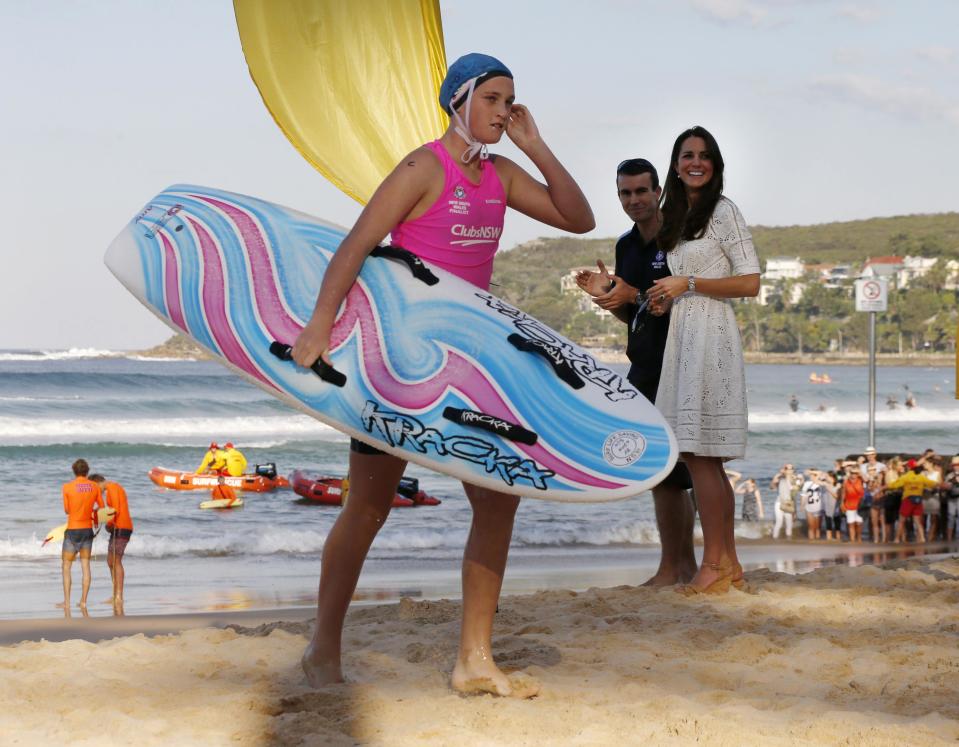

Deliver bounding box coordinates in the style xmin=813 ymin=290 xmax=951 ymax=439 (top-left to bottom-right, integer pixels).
xmin=302 ymin=451 xmax=406 ymax=687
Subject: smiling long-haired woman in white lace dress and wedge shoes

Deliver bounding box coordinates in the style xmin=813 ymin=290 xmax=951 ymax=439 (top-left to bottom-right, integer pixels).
xmin=648 ymin=127 xmax=759 ymax=594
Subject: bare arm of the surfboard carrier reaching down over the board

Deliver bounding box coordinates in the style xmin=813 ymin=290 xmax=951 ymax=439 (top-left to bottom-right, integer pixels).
xmin=293 ymin=148 xmax=441 ymax=366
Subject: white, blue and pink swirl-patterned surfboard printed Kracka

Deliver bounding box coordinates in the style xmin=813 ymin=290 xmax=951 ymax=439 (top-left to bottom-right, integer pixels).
xmin=105 ymin=185 xmax=676 ymax=502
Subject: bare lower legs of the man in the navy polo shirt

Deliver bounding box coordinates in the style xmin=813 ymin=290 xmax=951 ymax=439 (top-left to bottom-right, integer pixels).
xmin=643 ymin=484 xmax=696 ymax=586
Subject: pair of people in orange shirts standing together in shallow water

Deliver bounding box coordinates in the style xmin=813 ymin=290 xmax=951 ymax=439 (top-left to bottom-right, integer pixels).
xmin=57 ymin=459 xmax=133 ymax=615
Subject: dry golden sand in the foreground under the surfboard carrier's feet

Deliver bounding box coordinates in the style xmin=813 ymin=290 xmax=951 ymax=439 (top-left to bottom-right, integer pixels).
xmin=0 ymin=556 xmax=959 ymax=745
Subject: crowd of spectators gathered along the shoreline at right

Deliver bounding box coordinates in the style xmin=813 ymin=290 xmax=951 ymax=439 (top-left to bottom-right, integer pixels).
xmin=752 ymin=447 xmax=959 ymax=544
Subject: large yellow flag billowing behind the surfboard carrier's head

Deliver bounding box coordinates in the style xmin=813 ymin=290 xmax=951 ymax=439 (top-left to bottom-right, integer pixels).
xmin=233 ymin=0 xmax=449 ymax=203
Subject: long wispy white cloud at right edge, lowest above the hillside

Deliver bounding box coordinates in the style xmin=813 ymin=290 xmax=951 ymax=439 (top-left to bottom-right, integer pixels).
xmin=811 ymin=73 xmax=959 ymax=125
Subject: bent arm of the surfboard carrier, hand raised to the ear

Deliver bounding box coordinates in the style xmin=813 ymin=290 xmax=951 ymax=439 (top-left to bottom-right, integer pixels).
xmin=495 ymin=104 xmax=596 ymax=233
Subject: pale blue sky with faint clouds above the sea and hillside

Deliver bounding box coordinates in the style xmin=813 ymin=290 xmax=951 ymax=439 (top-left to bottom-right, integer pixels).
xmin=0 ymin=0 xmax=959 ymax=349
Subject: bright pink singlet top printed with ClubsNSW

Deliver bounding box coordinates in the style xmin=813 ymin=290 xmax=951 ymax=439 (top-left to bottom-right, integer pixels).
xmin=390 ymin=140 xmax=506 ymax=289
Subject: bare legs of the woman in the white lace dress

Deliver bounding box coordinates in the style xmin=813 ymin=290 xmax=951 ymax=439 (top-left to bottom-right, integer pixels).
xmin=682 ymin=453 xmax=739 ymax=591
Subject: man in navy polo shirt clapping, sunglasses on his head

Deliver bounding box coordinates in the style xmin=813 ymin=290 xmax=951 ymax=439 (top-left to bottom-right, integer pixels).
xmin=576 ymin=158 xmax=696 ymax=586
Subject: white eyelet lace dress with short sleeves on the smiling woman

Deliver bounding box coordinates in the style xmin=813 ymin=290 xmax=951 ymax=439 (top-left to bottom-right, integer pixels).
xmin=656 ymin=197 xmax=759 ymax=460
